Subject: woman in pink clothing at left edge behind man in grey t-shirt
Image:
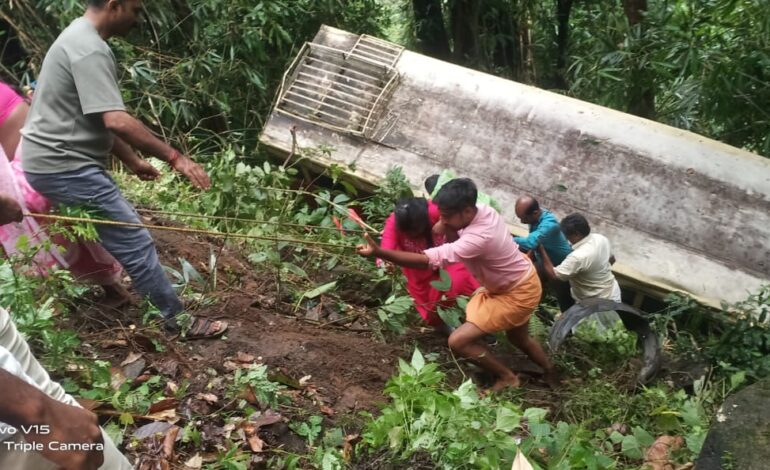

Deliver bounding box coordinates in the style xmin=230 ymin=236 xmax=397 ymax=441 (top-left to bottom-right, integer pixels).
xmin=0 ymin=82 xmax=128 ymax=306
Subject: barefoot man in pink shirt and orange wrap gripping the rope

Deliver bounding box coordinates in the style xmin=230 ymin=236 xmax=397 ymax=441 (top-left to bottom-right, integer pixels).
xmin=358 ymin=178 xmax=553 ymax=391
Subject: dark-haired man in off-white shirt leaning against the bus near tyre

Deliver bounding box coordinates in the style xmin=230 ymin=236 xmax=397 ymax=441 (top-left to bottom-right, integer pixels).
xmin=538 ymin=213 xmax=621 ymax=326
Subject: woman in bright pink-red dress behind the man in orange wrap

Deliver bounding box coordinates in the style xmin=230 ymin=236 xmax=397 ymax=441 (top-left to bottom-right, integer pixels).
xmin=382 ymin=198 xmax=479 ymax=334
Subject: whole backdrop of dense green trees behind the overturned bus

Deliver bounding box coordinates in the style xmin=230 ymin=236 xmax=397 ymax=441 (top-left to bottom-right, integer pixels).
xmin=0 ymin=0 xmax=770 ymax=156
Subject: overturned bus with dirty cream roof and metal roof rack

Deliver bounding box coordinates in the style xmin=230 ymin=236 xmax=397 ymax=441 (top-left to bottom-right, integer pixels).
xmin=260 ymin=26 xmax=770 ymax=309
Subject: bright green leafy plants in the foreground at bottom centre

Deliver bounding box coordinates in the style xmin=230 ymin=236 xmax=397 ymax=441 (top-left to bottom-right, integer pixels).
xmin=363 ymin=350 xmax=614 ymax=469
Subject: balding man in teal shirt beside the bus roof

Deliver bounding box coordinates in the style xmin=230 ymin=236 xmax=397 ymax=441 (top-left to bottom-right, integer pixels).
xmin=513 ymin=196 xmax=575 ymax=312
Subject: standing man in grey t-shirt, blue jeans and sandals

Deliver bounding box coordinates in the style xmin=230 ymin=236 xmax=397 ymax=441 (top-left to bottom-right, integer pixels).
xmin=21 ymin=0 xmax=227 ymax=337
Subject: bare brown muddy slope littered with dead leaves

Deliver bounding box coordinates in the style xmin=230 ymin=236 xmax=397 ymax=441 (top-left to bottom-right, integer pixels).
xmin=64 ymin=221 xmax=557 ymax=469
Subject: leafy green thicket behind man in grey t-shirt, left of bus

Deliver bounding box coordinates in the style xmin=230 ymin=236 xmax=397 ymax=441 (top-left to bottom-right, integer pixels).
xmin=0 ymin=0 xmax=387 ymax=149
